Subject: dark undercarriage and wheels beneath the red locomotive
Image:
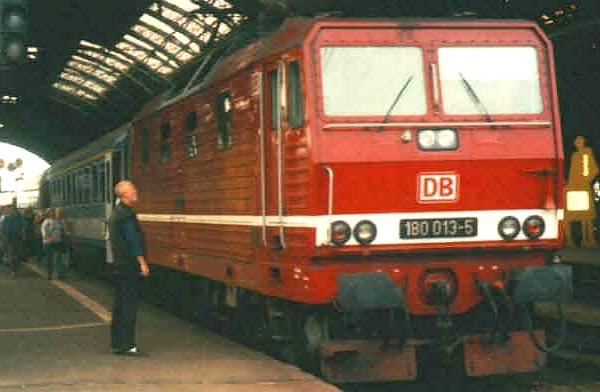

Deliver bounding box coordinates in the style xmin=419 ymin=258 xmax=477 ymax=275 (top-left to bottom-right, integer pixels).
xmin=138 ymin=267 xmax=568 ymax=382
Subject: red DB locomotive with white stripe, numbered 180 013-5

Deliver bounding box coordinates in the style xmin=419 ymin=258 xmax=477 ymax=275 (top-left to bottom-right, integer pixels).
xmin=43 ymin=18 xmax=569 ymax=382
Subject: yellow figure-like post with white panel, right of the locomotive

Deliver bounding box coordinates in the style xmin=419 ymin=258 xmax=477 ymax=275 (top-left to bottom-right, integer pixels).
xmin=565 ymin=136 xmax=598 ymax=248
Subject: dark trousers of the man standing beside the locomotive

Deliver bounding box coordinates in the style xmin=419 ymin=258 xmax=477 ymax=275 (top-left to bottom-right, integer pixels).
xmin=110 ymin=261 xmax=140 ymax=352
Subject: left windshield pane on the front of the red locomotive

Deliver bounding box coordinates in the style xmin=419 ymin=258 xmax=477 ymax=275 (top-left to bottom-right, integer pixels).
xmin=320 ymin=46 xmax=427 ymax=116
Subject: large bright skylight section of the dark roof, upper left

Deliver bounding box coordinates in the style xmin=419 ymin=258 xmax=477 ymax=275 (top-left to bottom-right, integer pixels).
xmin=53 ymin=0 xmax=245 ymax=113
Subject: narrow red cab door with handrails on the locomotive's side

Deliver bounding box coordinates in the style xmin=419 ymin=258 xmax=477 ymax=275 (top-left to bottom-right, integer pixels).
xmin=261 ymin=61 xmax=286 ymax=249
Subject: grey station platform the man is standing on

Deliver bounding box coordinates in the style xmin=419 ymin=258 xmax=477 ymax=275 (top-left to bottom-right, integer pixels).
xmin=0 ymin=261 xmax=338 ymax=392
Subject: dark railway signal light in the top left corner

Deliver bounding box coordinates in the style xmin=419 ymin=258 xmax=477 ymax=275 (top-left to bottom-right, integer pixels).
xmin=0 ymin=0 xmax=29 ymax=66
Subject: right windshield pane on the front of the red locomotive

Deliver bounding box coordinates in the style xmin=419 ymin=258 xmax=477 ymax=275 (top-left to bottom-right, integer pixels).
xmin=438 ymin=46 xmax=542 ymax=115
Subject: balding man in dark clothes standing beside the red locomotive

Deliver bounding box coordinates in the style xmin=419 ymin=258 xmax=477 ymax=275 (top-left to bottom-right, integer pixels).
xmin=108 ymin=181 xmax=150 ymax=356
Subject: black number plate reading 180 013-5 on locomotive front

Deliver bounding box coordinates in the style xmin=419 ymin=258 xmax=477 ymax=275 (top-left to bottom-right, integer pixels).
xmin=400 ymin=218 xmax=477 ymax=240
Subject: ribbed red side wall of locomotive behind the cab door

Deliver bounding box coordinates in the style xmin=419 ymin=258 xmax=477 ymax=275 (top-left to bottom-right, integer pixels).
xmin=134 ymin=69 xmax=258 ymax=279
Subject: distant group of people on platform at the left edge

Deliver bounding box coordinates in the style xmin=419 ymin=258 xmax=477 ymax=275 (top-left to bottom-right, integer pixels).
xmin=0 ymin=203 xmax=69 ymax=279
